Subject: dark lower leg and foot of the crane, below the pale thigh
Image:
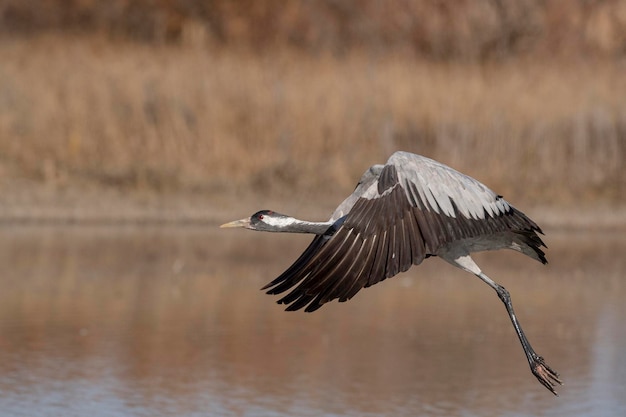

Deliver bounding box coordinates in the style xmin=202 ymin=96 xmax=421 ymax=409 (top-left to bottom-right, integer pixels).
xmin=476 ymin=272 xmax=562 ymax=395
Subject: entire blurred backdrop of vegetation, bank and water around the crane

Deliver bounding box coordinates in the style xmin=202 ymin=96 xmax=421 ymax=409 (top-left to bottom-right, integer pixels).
xmin=0 ymin=0 xmax=626 ymax=416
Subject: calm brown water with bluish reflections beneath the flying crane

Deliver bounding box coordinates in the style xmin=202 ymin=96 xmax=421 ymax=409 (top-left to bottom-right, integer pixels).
xmin=0 ymin=226 xmax=626 ymax=417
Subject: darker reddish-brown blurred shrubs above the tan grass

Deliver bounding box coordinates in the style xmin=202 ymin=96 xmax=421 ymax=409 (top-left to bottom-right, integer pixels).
xmin=0 ymin=0 xmax=626 ymax=60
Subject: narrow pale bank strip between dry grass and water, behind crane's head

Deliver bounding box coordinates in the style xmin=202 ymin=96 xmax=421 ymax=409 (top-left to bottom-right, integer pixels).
xmin=0 ymin=184 xmax=626 ymax=231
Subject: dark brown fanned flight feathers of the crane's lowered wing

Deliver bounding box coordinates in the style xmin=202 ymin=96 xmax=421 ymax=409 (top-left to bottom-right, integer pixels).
xmin=264 ymin=166 xmax=426 ymax=311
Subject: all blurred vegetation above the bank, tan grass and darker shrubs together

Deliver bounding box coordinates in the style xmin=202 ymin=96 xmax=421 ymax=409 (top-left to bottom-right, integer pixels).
xmin=0 ymin=0 xmax=626 ymax=208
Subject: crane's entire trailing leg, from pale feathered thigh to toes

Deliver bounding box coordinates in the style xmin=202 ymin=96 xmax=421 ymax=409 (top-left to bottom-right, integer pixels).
xmin=441 ymin=252 xmax=562 ymax=395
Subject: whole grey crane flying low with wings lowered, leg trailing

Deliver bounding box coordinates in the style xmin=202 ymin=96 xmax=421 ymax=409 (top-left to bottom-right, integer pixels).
xmin=223 ymin=152 xmax=561 ymax=394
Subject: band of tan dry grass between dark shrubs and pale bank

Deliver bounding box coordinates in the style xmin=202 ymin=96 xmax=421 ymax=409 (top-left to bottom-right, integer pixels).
xmin=0 ymin=37 xmax=626 ymax=203
